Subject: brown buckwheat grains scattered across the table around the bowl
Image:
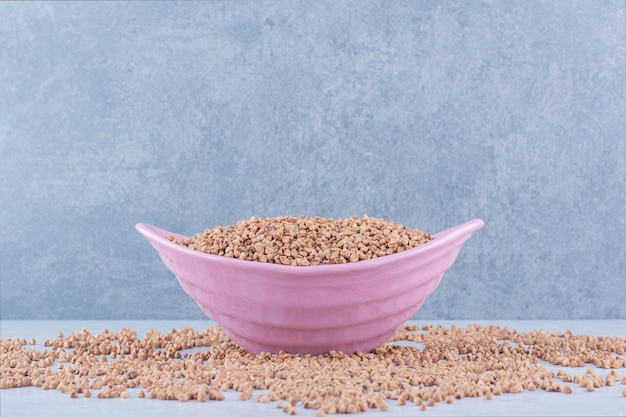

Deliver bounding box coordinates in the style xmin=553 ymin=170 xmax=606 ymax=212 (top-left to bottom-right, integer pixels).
xmin=0 ymin=325 xmax=626 ymax=417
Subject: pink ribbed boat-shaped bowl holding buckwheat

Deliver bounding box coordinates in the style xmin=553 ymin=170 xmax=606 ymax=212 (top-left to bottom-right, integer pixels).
xmin=135 ymin=219 xmax=484 ymax=355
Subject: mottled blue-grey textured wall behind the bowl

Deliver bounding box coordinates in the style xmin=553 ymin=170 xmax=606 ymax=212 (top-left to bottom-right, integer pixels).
xmin=0 ymin=0 xmax=626 ymax=319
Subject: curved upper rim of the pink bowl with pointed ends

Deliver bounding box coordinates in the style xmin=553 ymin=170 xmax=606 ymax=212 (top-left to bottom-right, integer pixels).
xmin=135 ymin=218 xmax=485 ymax=275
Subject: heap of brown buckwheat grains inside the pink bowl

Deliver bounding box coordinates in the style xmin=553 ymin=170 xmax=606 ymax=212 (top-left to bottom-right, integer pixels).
xmin=168 ymin=216 xmax=433 ymax=266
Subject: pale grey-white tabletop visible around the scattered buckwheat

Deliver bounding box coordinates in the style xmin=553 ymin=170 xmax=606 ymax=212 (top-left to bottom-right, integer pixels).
xmin=0 ymin=320 xmax=626 ymax=417
